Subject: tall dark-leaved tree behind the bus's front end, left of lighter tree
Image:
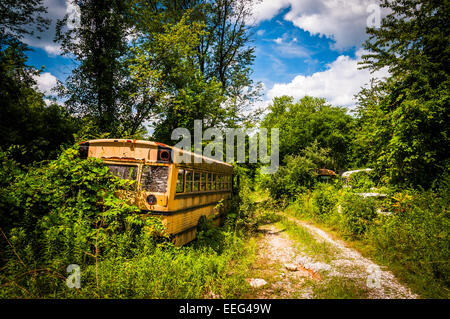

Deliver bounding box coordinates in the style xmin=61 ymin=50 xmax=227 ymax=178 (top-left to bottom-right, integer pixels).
xmin=55 ymin=0 xmax=135 ymax=136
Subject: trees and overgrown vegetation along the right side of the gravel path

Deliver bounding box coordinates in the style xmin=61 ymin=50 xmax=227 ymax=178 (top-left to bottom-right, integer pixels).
xmin=255 ymin=0 xmax=450 ymax=298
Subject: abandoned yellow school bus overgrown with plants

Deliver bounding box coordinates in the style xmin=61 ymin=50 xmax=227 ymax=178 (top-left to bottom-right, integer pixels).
xmin=80 ymin=139 xmax=233 ymax=246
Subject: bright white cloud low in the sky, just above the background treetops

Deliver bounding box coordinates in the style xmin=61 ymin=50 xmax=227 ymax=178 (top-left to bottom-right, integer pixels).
xmin=266 ymin=49 xmax=388 ymax=108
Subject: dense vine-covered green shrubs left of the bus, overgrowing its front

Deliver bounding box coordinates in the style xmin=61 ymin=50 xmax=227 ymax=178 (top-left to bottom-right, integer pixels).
xmin=0 ymin=148 xmax=162 ymax=298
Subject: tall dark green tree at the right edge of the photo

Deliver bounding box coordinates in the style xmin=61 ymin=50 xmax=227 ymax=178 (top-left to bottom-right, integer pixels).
xmin=359 ymin=0 xmax=450 ymax=187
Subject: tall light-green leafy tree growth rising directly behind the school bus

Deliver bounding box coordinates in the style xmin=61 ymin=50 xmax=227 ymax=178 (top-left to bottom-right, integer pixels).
xmin=132 ymin=0 xmax=259 ymax=141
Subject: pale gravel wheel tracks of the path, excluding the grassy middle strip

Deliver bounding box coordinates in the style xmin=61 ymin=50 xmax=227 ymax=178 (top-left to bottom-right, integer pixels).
xmin=249 ymin=214 xmax=419 ymax=299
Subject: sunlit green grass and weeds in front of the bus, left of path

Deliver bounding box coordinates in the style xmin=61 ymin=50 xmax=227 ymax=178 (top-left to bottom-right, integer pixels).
xmin=0 ymin=230 xmax=256 ymax=299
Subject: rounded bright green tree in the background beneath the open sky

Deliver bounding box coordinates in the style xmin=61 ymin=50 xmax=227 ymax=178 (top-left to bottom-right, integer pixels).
xmin=261 ymin=96 xmax=354 ymax=169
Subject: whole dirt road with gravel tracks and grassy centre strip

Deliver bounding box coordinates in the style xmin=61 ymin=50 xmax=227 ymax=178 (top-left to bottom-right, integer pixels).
xmin=249 ymin=215 xmax=419 ymax=299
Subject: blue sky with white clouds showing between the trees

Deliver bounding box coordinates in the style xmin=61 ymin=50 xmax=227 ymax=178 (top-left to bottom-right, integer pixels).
xmin=25 ymin=0 xmax=388 ymax=109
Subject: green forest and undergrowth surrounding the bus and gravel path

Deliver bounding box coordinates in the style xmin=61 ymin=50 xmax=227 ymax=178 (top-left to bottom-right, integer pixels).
xmin=0 ymin=0 xmax=450 ymax=299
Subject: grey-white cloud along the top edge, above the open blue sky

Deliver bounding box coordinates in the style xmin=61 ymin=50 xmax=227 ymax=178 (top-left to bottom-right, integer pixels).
xmin=253 ymin=0 xmax=384 ymax=50
